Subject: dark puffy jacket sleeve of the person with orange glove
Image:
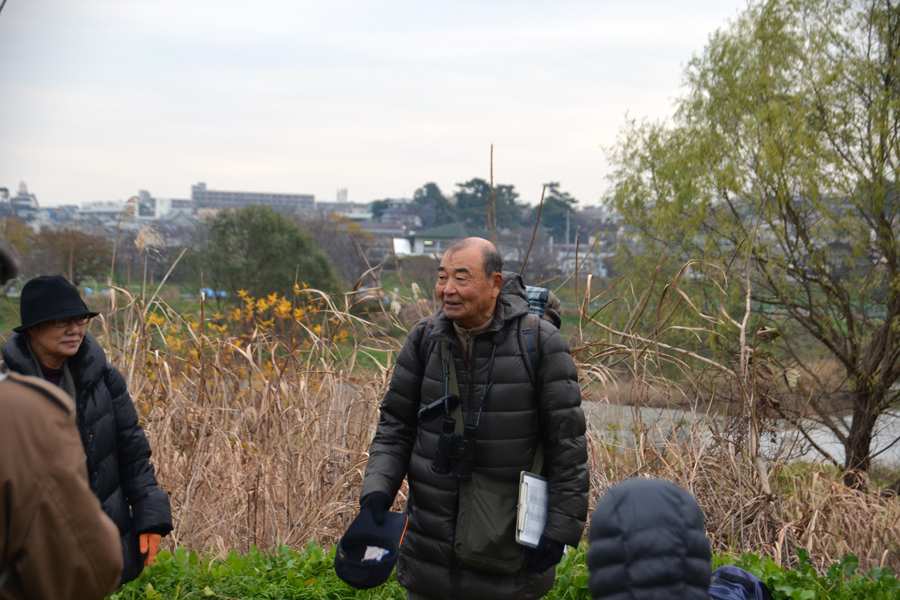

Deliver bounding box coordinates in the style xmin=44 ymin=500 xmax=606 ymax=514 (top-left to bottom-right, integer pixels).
xmin=105 ymin=363 xmax=172 ymax=535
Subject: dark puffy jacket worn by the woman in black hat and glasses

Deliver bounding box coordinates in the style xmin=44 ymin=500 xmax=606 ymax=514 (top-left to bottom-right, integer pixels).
xmin=2 ymin=333 xmax=172 ymax=583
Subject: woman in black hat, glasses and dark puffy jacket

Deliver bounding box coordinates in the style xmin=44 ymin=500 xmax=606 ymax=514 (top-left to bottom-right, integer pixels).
xmin=2 ymin=275 xmax=172 ymax=583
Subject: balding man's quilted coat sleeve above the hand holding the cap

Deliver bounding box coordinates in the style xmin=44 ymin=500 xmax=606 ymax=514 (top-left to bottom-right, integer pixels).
xmin=360 ymin=319 xmax=427 ymax=498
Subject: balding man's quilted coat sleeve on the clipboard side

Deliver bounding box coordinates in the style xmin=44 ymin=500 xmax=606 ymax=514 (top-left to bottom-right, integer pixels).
xmin=538 ymin=321 xmax=590 ymax=546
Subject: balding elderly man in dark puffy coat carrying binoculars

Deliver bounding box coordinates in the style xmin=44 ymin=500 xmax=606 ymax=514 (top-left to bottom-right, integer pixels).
xmin=361 ymin=238 xmax=589 ymax=600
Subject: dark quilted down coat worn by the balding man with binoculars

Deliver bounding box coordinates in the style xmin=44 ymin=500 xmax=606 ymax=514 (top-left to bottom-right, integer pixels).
xmin=361 ymin=273 xmax=589 ymax=600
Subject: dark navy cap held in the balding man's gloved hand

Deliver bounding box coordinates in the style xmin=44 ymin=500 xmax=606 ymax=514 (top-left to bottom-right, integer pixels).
xmin=334 ymin=510 xmax=409 ymax=590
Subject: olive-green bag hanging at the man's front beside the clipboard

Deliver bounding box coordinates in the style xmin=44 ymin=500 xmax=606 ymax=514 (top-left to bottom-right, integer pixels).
xmin=455 ymin=473 xmax=525 ymax=575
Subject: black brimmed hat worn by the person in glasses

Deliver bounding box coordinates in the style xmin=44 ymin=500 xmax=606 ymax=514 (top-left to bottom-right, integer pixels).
xmin=13 ymin=275 xmax=100 ymax=333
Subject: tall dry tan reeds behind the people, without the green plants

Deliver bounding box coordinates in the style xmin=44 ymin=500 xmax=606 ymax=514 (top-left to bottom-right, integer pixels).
xmin=98 ymin=264 xmax=900 ymax=571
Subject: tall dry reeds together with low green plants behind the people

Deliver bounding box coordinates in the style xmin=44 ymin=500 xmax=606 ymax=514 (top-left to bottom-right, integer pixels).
xmin=7 ymin=214 xmax=900 ymax=600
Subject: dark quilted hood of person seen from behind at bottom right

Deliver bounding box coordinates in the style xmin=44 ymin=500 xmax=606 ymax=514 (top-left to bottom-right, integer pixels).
xmin=587 ymin=479 xmax=712 ymax=600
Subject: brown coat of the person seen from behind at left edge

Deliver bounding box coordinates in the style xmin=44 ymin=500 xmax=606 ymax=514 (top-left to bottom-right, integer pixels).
xmin=0 ymin=373 xmax=122 ymax=600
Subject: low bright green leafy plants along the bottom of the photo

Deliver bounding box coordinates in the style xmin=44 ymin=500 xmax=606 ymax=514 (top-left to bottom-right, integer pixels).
xmin=110 ymin=542 xmax=900 ymax=600
